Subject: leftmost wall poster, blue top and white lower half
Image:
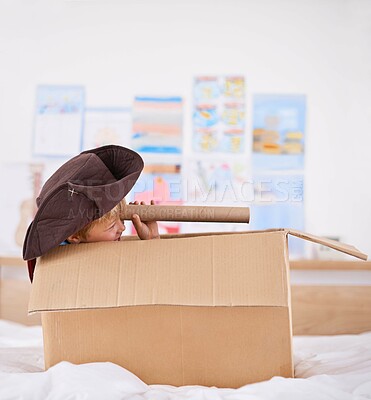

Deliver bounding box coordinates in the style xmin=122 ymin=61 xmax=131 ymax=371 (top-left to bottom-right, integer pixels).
xmin=33 ymin=86 xmax=85 ymax=157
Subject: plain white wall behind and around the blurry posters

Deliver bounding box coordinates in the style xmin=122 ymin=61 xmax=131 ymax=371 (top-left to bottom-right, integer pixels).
xmin=0 ymin=0 xmax=371 ymax=253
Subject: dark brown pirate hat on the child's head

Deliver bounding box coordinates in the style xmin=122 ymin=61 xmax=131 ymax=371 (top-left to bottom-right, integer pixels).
xmin=23 ymin=145 xmax=144 ymax=260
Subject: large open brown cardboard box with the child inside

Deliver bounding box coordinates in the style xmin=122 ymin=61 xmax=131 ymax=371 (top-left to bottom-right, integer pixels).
xmin=29 ymin=230 xmax=365 ymax=387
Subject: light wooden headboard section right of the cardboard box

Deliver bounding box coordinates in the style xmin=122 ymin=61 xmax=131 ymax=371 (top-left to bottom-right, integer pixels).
xmin=290 ymin=260 xmax=371 ymax=335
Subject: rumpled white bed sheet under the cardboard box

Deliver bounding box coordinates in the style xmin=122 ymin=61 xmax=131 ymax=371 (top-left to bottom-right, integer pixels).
xmin=0 ymin=320 xmax=371 ymax=400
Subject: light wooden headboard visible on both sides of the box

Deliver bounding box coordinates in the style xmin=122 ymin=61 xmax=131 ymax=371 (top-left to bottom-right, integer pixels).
xmin=0 ymin=257 xmax=371 ymax=335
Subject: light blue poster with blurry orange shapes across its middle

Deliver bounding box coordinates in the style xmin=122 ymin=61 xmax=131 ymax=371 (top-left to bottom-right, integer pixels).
xmin=252 ymin=94 xmax=306 ymax=170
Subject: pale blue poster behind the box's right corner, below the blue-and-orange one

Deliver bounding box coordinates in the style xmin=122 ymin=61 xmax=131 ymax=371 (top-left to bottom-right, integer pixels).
xmin=250 ymin=172 xmax=305 ymax=257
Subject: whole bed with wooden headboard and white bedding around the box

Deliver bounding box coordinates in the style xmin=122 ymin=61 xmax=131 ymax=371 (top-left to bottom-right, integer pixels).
xmin=0 ymin=258 xmax=371 ymax=399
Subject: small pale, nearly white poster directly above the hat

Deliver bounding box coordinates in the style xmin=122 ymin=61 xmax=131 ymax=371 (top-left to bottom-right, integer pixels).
xmin=82 ymin=108 xmax=132 ymax=150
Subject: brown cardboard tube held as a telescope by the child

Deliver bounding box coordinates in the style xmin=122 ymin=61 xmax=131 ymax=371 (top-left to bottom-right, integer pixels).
xmin=121 ymin=204 xmax=250 ymax=223
